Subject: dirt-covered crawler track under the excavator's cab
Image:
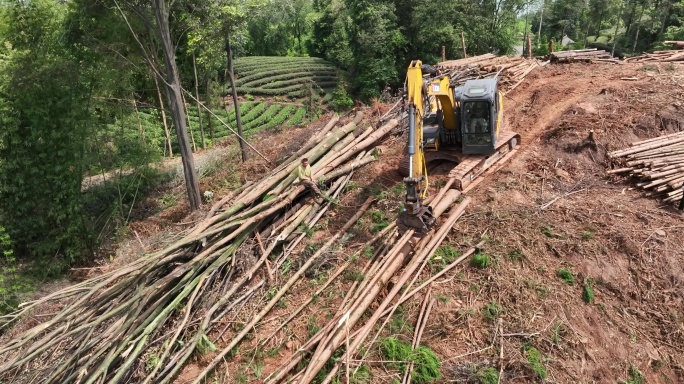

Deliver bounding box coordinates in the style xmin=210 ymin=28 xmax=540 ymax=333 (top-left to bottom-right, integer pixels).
xmin=449 ymin=132 xmax=520 ymax=191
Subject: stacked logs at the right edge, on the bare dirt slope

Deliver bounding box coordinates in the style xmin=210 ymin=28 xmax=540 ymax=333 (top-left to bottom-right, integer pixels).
xmin=608 ymin=132 xmax=684 ymax=203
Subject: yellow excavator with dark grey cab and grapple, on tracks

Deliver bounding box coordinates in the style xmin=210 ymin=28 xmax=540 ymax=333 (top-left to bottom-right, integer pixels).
xmin=398 ymin=60 xmax=520 ymax=234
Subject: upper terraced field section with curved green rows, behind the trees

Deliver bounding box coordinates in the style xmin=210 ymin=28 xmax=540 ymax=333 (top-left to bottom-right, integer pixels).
xmin=235 ymin=56 xmax=338 ymax=101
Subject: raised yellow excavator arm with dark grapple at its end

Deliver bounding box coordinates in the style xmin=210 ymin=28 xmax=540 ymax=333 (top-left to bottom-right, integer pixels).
xmin=398 ymin=60 xmax=435 ymax=234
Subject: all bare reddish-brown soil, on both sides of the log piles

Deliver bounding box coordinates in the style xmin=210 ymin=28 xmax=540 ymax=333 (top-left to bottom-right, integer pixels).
xmin=33 ymin=64 xmax=684 ymax=383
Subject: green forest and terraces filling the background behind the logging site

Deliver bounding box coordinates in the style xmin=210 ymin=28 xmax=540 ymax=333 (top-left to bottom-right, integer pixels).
xmin=0 ymin=0 xmax=684 ymax=300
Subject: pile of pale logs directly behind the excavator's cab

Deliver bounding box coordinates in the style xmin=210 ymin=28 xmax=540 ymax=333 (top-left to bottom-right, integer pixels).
xmin=436 ymin=53 xmax=548 ymax=92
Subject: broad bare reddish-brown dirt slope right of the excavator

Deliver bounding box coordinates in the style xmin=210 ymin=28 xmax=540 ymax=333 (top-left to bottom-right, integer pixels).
xmin=429 ymin=65 xmax=684 ymax=383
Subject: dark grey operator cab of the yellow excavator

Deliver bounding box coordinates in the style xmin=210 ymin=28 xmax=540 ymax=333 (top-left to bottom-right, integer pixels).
xmin=457 ymin=79 xmax=503 ymax=155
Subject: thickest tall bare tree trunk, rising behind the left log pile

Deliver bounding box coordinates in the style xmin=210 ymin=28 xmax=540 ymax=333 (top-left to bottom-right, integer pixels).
xmin=152 ymin=0 xmax=202 ymax=211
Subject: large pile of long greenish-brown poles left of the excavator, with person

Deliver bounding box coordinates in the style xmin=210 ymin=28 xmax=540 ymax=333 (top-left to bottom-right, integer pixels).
xmin=0 ymin=112 xmax=455 ymax=383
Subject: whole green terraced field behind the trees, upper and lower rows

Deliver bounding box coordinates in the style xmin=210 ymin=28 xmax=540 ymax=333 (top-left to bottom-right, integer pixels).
xmin=108 ymin=56 xmax=337 ymax=153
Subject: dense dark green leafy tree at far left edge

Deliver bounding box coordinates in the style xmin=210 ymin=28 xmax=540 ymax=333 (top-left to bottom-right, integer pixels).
xmin=0 ymin=0 xmax=94 ymax=266
